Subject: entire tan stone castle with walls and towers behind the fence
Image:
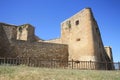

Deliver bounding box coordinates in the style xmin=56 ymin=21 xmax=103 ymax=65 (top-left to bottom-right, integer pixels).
xmin=0 ymin=8 xmax=113 ymax=68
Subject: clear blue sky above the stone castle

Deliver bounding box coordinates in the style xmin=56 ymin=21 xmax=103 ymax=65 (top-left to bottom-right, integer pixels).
xmin=0 ymin=0 xmax=120 ymax=61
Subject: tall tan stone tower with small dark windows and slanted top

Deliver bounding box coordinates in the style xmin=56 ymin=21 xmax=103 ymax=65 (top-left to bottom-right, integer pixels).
xmin=61 ymin=8 xmax=107 ymax=61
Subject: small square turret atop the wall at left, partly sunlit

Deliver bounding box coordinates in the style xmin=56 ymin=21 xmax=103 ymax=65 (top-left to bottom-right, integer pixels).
xmin=17 ymin=24 xmax=35 ymax=41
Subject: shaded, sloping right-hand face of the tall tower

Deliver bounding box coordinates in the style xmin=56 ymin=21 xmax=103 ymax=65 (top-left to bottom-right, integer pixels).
xmin=91 ymin=15 xmax=110 ymax=61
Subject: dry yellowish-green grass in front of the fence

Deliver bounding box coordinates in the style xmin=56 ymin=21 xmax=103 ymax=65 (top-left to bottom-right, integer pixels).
xmin=0 ymin=66 xmax=120 ymax=80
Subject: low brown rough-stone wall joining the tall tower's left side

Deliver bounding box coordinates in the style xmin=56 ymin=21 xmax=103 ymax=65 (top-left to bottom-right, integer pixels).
xmin=13 ymin=41 xmax=68 ymax=61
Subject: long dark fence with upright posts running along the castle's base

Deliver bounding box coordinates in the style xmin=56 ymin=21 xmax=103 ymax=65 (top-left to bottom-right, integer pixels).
xmin=0 ymin=57 xmax=120 ymax=70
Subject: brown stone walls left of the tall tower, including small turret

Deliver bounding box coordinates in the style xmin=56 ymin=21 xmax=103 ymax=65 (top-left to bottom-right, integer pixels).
xmin=0 ymin=23 xmax=68 ymax=61
